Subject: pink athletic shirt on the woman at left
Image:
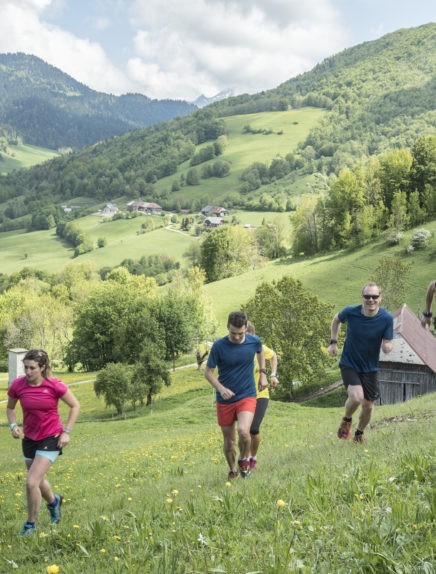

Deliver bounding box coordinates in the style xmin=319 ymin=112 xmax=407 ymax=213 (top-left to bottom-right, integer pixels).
xmin=8 ymin=377 xmax=68 ymax=440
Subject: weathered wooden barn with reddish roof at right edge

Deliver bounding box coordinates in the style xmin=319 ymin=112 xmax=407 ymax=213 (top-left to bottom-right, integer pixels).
xmin=378 ymin=305 xmax=436 ymax=405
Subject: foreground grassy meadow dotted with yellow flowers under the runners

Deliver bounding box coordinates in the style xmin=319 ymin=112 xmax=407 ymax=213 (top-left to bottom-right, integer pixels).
xmin=0 ymin=367 xmax=436 ymax=574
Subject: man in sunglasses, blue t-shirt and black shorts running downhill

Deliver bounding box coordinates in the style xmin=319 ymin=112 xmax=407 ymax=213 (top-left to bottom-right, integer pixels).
xmin=328 ymin=283 xmax=394 ymax=443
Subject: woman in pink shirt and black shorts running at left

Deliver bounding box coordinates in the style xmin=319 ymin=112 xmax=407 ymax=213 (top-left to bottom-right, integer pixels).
xmin=6 ymin=349 xmax=80 ymax=536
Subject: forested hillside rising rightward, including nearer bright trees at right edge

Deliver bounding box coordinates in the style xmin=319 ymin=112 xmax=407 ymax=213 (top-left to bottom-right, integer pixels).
xmin=0 ymin=24 xmax=436 ymax=246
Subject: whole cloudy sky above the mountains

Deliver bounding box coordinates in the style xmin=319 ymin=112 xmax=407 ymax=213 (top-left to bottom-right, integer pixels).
xmin=0 ymin=0 xmax=436 ymax=101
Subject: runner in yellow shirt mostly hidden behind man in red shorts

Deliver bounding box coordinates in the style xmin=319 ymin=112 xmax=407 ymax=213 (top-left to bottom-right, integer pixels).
xmin=247 ymin=321 xmax=279 ymax=470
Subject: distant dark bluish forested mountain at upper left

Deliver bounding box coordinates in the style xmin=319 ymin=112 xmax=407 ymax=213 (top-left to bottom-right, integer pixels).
xmin=0 ymin=54 xmax=196 ymax=149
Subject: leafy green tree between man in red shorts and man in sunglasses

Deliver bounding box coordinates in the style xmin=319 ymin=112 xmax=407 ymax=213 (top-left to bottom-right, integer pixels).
xmin=244 ymin=277 xmax=332 ymax=400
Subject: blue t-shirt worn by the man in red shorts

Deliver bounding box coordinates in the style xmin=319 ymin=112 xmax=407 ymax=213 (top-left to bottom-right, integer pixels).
xmin=207 ymin=333 xmax=262 ymax=403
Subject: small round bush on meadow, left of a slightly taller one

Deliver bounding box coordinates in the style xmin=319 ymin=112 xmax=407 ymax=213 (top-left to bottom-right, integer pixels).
xmin=94 ymin=363 xmax=133 ymax=415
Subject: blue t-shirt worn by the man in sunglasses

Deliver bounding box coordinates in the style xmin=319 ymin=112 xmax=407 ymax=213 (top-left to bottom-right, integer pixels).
xmin=338 ymin=305 xmax=394 ymax=373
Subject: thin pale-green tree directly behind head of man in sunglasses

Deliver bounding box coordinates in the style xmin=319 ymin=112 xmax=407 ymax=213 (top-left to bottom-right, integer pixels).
xmin=374 ymin=256 xmax=412 ymax=311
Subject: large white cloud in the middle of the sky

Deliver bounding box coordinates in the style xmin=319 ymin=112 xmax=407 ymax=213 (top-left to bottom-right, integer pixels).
xmin=128 ymin=0 xmax=344 ymax=99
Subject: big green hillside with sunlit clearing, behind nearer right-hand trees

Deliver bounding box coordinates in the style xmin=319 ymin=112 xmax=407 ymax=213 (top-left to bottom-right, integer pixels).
xmin=0 ymin=24 xmax=436 ymax=230
